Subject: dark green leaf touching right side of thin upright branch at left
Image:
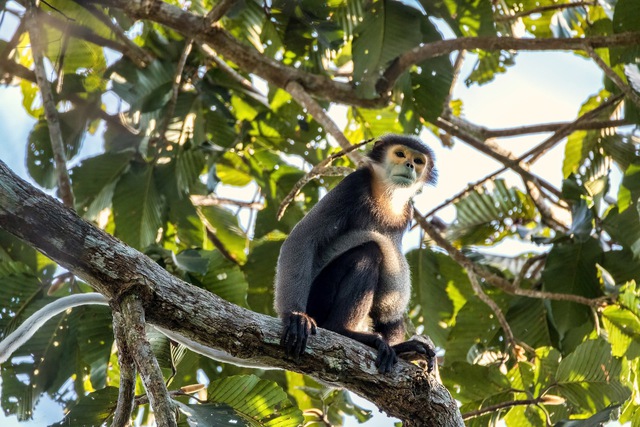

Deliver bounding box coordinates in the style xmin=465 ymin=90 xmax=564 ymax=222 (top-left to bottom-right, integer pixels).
xmin=71 ymin=150 xmax=134 ymax=219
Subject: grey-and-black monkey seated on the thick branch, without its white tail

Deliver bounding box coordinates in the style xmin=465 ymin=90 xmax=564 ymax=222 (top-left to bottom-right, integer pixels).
xmin=274 ymin=135 xmax=437 ymax=374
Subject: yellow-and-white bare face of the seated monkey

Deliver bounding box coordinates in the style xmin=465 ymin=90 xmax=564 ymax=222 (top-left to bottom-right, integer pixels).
xmin=384 ymin=144 xmax=427 ymax=187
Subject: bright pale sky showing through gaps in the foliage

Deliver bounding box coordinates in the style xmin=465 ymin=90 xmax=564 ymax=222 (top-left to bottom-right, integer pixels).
xmin=0 ymin=5 xmax=616 ymax=427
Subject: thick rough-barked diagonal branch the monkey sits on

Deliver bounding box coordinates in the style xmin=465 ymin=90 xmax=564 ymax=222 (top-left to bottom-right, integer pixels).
xmin=0 ymin=161 xmax=463 ymax=426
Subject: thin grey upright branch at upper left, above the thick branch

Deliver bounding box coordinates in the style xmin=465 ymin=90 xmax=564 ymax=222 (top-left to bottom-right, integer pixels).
xmin=26 ymin=0 xmax=75 ymax=209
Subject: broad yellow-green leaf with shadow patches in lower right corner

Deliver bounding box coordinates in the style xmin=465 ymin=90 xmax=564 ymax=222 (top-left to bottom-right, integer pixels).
xmin=554 ymin=339 xmax=630 ymax=412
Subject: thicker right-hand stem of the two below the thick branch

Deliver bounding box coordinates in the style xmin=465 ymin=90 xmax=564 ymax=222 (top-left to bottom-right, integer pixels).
xmin=121 ymin=294 xmax=178 ymax=427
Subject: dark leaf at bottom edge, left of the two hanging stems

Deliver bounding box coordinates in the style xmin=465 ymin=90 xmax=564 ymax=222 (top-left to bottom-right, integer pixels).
xmin=51 ymin=387 xmax=118 ymax=427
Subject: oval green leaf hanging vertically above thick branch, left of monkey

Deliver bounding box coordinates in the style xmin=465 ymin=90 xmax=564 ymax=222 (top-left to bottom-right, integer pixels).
xmin=113 ymin=164 xmax=164 ymax=249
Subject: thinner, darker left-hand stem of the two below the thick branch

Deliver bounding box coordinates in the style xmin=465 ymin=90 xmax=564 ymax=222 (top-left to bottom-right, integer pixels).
xmin=111 ymin=311 xmax=136 ymax=427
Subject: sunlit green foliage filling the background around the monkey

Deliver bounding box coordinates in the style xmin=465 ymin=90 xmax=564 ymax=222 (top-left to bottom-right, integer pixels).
xmin=0 ymin=0 xmax=640 ymax=426
